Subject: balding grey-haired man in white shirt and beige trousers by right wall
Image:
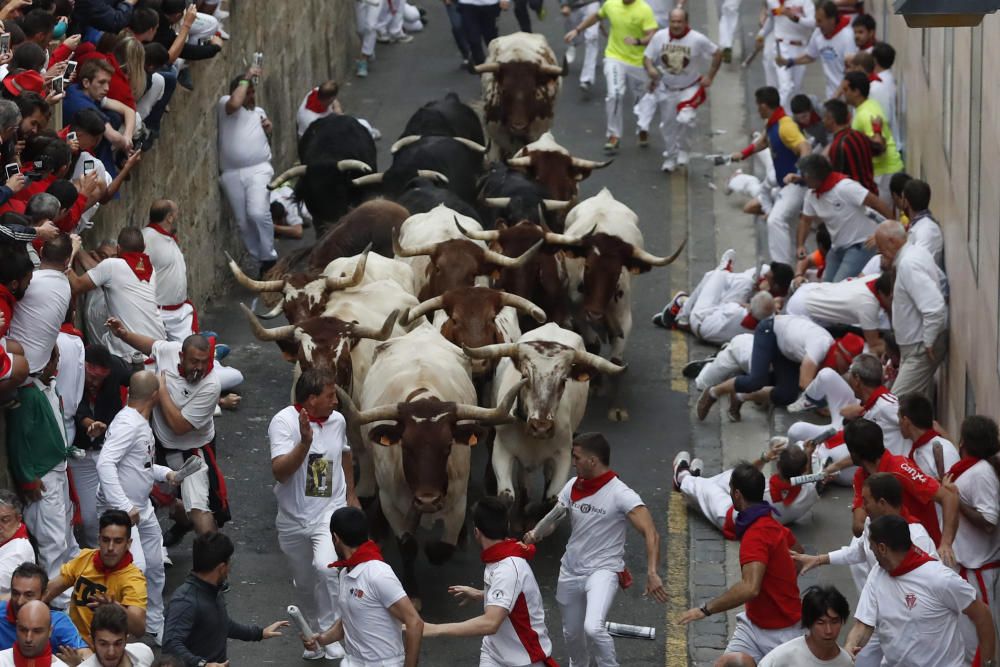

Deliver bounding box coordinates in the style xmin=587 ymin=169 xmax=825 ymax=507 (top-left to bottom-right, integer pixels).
xmin=875 ymin=220 xmax=948 ymax=402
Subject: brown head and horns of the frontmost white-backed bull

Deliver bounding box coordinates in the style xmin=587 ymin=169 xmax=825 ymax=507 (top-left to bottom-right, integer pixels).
xmin=337 ymin=385 xmax=520 ymax=513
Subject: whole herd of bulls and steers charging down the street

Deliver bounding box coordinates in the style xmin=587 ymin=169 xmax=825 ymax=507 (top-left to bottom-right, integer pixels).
xmin=230 ymin=33 xmax=683 ymax=594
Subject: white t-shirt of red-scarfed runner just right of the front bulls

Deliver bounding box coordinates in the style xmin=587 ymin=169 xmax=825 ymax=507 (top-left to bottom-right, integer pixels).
xmin=558 ymin=477 xmax=645 ymax=576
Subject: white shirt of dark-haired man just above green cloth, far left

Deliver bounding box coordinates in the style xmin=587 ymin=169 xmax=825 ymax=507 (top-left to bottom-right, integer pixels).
xmin=7 ymin=269 xmax=72 ymax=373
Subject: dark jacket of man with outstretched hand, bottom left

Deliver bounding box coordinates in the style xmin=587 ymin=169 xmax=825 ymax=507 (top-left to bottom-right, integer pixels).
xmin=163 ymin=573 xmax=264 ymax=667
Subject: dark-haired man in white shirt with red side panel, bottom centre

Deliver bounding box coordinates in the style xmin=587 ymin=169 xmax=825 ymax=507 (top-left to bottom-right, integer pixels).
xmin=424 ymin=497 xmax=560 ymax=667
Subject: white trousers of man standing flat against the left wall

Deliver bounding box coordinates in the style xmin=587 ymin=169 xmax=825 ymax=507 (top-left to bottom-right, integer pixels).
xmin=220 ymin=162 xmax=278 ymax=262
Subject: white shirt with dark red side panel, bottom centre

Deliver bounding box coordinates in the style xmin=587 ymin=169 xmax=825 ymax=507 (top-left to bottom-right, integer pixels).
xmin=482 ymin=556 xmax=552 ymax=665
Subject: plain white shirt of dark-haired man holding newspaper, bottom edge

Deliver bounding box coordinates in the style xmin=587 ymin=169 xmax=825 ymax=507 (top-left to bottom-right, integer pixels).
xmin=338 ymin=560 xmax=406 ymax=662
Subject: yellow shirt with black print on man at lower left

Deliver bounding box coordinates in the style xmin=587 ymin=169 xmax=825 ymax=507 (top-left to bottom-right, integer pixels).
xmin=59 ymin=549 xmax=146 ymax=643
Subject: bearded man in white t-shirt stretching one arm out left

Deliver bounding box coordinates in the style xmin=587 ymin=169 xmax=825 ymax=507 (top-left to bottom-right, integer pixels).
xmin=108 ymin=317 xmax=229 ymax=547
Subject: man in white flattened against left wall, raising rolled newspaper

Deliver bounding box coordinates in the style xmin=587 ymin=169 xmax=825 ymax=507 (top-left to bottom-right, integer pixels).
xmin=218 ymin=67 xmax=278 ymax=275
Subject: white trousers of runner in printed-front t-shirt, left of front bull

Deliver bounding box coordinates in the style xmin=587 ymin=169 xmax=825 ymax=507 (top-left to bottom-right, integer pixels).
xmin=275 ymin=512 xmax=340 ymax=632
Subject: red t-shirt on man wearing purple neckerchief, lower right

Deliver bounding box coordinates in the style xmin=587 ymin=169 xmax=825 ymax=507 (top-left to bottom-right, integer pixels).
xmin=740 ymin=515 xmax=802 ymax=630
